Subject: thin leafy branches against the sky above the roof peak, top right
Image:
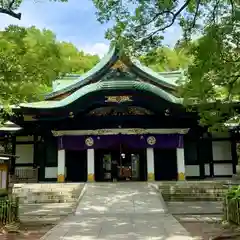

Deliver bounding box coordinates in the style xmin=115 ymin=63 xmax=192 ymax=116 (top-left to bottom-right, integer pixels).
xmin=93 ymin=0 xmax=240 ymax=54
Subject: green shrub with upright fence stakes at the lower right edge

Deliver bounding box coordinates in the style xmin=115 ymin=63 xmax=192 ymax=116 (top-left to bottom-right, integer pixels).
xmin=223 ymin=186 xmax=240 ymax=225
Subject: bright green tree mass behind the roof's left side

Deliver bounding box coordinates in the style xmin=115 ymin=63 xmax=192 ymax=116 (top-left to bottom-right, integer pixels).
xmin=0 ymin=26 xmax=99 ymax=105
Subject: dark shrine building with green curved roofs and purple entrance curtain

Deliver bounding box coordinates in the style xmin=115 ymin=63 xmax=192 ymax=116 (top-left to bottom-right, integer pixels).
xmin=0 ymin=47 xmax=237 ymax=182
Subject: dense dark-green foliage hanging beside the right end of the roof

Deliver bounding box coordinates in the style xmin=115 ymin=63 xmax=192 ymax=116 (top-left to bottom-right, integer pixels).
xmin=179 ymin=19 xmax=240 ymax=130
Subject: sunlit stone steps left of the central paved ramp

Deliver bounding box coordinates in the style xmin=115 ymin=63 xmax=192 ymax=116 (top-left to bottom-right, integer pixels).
xmin=12 ymin=183 xmax=85 ymax=224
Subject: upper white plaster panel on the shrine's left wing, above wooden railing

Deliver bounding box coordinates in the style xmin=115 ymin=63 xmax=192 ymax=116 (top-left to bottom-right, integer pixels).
xmin=16 ymin=144 xmax=34 ymax=164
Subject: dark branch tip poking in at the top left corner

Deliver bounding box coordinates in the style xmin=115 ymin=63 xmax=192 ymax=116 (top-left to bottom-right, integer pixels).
xmin=0 ymin=0 xmax=67 ymax=20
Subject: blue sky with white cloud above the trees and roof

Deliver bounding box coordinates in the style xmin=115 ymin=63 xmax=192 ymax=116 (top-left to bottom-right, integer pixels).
xmin=0 ymin=0 xmax=181 ymax=56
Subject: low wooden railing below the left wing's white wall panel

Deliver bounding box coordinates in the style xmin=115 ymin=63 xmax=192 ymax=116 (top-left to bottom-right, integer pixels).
xmin=12 ymin=168 xmax=38 ymax=183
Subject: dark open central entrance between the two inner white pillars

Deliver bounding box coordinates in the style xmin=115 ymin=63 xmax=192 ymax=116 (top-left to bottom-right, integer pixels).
xmin=95 ymin=144 xmax=147 ymax=181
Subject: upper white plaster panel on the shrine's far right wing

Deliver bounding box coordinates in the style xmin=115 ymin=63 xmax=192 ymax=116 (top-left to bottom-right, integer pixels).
xmin=212 ymin=141 xmax=232 ymax=161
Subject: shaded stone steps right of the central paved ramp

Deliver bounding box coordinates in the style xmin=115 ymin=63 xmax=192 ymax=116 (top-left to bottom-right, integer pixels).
xmin=158 ymin=181 xmax=229 ymax=202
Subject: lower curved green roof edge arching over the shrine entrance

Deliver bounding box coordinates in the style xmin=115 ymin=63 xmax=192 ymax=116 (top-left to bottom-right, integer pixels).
xmin=20 ymin=80 xmax=182 ymax=109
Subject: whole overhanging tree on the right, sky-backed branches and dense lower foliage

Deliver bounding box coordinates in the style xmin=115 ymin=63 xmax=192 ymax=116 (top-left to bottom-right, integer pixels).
xmin=93 ymin=0 xmax=240 ymax=129
